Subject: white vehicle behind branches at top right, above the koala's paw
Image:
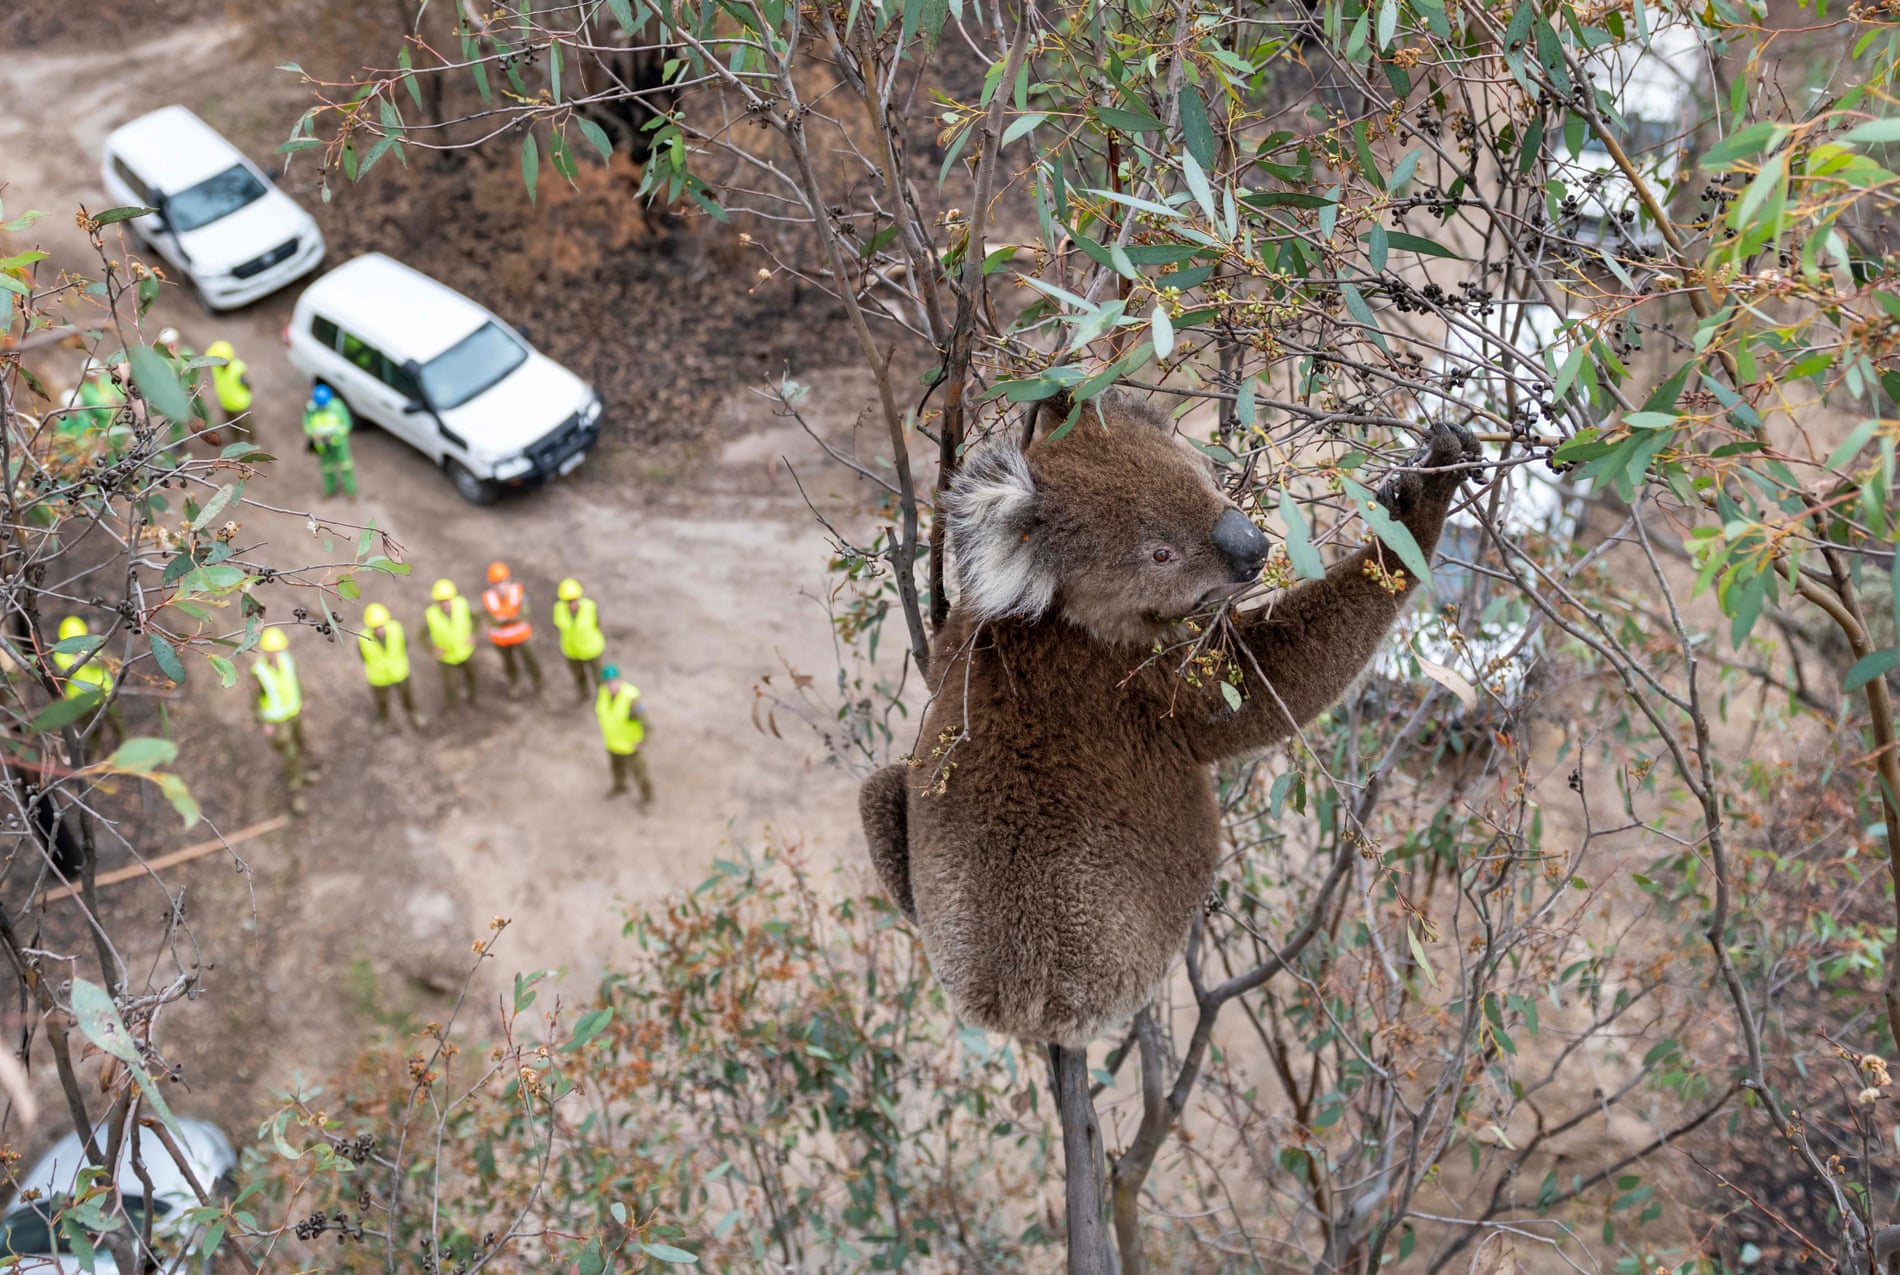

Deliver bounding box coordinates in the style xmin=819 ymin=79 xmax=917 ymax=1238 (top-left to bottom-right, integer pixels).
xmin=1552 ymin=21 xmax=1708 ymax=249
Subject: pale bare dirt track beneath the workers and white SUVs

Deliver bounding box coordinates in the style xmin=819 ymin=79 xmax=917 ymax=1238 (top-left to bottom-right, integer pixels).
xmin=0 ymin=23 xmax=895 ymax=1132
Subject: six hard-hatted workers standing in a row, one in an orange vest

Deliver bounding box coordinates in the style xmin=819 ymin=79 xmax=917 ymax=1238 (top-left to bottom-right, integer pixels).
xmin=241 ymin=562 xmax=654 ymax=813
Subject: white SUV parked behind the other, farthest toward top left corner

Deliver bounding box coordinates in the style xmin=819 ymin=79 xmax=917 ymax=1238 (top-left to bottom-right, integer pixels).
xmin=101 ymin=106 xmax=323 ymax=312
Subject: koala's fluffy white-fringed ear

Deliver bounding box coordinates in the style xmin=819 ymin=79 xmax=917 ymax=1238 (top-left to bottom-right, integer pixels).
xmin=942 ymin=437 xmax=1056 ymax=623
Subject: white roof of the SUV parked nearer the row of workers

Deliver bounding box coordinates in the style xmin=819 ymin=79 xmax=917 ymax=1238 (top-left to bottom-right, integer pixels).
xmin=296 ymin=253 xmax=494 ymax=363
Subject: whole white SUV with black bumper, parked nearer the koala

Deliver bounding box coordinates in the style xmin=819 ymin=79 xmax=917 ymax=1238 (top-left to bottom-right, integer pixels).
xmin=283 ymin=253 xmax=600 ymax=505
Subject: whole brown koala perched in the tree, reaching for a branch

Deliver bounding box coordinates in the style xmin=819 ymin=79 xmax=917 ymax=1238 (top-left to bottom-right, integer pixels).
xmin=859 ymin=393 xmax=1478 ymax=1047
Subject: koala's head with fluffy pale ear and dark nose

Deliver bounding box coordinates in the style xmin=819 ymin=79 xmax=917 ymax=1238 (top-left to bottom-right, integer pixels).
xmin=942 ymin=395 xmax=1267 ymax=642
